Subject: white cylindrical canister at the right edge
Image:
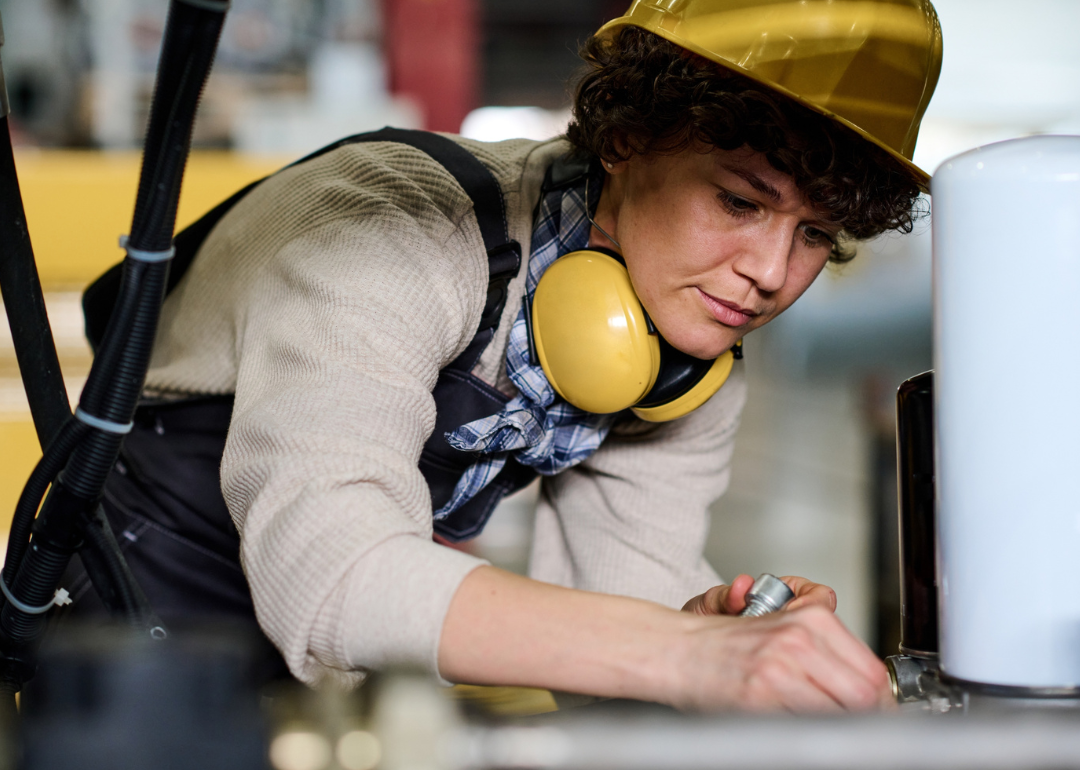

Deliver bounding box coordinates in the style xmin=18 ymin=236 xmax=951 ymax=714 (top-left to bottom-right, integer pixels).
xmin=931 ymin=136 xmax=1080 ymax=688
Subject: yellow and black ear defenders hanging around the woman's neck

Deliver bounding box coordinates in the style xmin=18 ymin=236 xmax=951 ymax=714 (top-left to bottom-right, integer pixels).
xmin=530 ymin=248 xmax=742 ymax=422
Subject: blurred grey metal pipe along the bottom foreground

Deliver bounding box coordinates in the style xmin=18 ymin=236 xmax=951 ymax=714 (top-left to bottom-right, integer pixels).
xmin=443 ymin=713 xmax=1080 ymax=770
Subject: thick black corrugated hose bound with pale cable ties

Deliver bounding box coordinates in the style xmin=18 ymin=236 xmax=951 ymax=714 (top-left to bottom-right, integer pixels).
xmin=0 ymin=0 xmax=229 ymax=698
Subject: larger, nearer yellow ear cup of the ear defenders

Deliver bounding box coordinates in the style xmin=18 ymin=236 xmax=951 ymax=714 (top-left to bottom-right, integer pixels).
xmin=532 ymin=251 xmax=660 ymax=415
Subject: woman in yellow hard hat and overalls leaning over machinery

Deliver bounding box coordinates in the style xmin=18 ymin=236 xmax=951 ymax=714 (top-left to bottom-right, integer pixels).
xmin=71 ymin=0 xmax=941 ymax=710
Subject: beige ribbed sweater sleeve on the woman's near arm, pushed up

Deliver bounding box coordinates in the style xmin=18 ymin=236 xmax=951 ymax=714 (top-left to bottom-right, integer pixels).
xmin=221 ymin=192 xmax=487 ymax=683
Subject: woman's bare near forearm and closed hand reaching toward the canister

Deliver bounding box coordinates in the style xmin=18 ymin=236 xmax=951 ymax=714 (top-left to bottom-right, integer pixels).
xmin=438 ymin=567 xmax=892 ymax=711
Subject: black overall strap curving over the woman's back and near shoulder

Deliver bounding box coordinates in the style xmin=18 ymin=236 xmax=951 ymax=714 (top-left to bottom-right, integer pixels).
xmin=82 ymin=127 xmax=522 ymax=350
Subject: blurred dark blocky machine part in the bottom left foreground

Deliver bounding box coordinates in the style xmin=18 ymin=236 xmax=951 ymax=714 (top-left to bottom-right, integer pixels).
xmin=19 ymin=626 xmax=268 ymax=770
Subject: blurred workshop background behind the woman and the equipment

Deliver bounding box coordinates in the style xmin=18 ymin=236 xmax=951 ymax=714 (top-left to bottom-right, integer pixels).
xmin=0 ymin=0 xmax=1080 ymax=653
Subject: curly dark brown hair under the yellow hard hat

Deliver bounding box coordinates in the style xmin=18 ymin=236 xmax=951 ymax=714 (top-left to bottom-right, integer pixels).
xmin=567 ymin=26 xmax=923 ymax=262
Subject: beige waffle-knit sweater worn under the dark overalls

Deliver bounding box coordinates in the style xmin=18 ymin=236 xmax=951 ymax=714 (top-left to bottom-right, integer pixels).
xmin=148 ymin=133 xmax=745 ymax=683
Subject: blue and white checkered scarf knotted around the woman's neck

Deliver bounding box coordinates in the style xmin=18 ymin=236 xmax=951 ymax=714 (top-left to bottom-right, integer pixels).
xmin=435 ymin=166 xmax=616 ymax=518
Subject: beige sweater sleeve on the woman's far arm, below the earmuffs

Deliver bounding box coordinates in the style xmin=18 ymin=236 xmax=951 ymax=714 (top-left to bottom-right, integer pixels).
xmin=529 ymin=362 xmax=746 ymax=608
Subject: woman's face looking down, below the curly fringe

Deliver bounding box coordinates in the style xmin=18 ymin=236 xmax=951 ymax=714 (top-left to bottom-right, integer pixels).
xmin=590 ymin=148 xmax=839 ymax=359
